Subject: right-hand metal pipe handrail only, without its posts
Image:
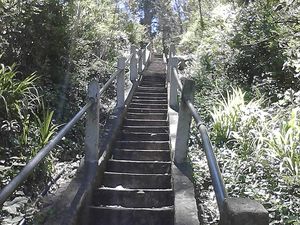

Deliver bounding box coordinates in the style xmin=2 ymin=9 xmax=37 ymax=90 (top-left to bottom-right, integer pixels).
xmin=172 ymin=64 xmax=228 ymax=211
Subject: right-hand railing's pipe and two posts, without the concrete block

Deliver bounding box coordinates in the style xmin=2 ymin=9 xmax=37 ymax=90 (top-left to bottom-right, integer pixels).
xmin=167 ymin=47 xmax=227 ymax=211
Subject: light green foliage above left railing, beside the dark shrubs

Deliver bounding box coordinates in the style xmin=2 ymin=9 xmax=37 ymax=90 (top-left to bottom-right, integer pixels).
xmin=56 ymin=0 xmax=144 ymax=121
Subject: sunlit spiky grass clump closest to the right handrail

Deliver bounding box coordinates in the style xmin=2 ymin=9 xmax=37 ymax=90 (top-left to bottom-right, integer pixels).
xmin=211 ymin=88 xmax=266 ymax=153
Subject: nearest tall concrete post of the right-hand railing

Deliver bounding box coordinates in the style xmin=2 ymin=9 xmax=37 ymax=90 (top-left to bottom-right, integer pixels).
xmin=174 ymin=78 xmax=194 ymax=163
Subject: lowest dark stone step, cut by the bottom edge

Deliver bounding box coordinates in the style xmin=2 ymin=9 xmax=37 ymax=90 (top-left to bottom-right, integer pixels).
xmin=89 ymin=206 xmax=174 ymax=225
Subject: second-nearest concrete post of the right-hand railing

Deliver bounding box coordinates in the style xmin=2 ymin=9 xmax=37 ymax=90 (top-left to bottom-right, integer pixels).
xmin=169 ymin=58 xmax=178 ymax=111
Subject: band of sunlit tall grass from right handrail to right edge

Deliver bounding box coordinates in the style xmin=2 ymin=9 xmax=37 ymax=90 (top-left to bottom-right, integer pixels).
xmin=211 ymin=88 xmax=300 ymax=176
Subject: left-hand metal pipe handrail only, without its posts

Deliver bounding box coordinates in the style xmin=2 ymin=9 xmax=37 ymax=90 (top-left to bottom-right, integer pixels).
xmin=0 ymin=48 xmax=138 ymax=207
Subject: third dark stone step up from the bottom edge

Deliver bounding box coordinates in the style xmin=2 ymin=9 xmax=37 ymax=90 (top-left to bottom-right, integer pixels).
xmin=103 ymin=172 xmax=171 ymax=189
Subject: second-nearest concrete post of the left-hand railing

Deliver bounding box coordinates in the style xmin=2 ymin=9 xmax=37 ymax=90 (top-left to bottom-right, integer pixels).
xmin=117 ymin=57 xmax=126 ymax=107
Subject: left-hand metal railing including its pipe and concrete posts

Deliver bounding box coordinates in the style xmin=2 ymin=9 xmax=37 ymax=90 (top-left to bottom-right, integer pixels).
xmin=0 ymin=43 xmax=151 ymax=208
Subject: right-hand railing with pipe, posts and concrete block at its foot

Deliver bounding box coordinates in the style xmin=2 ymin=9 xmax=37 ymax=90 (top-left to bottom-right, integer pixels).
xmin=167 ymin=45 xmax=268 ymax=225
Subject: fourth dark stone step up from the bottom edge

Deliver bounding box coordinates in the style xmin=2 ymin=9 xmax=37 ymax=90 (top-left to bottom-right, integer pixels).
xmin=106 ymin=159 xmax=171 ymax=174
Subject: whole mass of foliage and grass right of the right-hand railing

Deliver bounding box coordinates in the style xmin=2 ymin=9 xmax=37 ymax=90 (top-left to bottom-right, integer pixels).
xmin=185 ymin=1 xmax=300 ymax=217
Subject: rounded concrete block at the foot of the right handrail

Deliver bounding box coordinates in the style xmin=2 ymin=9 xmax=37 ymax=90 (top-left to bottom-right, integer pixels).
xmin=219 ymin=198 xmax=269 ymax=225
